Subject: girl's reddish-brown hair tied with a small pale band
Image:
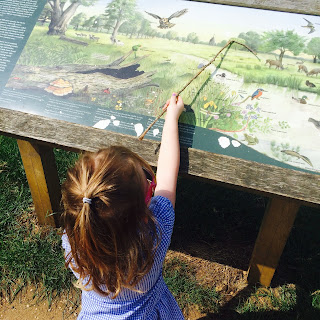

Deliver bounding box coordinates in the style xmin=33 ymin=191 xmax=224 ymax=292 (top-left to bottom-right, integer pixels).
xmin=62 ymin=147 xmax=159 ymax=298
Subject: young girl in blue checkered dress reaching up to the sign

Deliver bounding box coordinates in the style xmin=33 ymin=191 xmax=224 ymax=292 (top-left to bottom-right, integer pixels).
xmin=62 ymin=94 xmax=184 ymax=320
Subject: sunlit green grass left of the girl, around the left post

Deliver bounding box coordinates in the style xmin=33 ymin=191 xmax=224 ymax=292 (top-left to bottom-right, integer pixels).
xmin=0 ymin=136 xmax=71 ymax=303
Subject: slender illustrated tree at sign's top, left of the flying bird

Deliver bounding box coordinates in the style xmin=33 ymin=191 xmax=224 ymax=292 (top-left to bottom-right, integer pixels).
xmin=105 ymin=0 xmax=136 ymax=42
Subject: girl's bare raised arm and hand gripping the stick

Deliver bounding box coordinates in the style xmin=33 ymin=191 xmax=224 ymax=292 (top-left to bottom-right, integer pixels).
xmin=155 ymin=93 xmax=184 ymax=207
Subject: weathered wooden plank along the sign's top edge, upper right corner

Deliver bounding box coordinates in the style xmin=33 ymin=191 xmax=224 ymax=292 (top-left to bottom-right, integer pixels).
xmin=189 ymin=0 xmax=320 ymax=15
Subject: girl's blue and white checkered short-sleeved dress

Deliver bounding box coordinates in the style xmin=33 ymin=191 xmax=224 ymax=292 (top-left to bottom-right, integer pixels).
xmin=62 ymin=196 xmax=184 ymax=320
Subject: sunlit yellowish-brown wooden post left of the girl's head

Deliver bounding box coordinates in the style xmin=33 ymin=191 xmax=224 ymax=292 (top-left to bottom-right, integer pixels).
xmin=18 ymin=140 xmax=61 ymax=227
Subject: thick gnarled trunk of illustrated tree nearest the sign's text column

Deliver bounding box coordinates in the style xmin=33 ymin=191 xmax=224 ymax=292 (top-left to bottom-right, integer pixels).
xmin=48 ymin=0 xmax=98 ymax=35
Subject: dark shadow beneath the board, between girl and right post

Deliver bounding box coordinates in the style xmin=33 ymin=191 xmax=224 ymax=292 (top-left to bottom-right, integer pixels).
xmin=171 ymin=178 xmax=267 ymax=270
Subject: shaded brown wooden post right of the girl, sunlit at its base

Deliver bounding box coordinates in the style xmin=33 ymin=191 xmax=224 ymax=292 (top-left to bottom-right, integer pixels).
xmin=248 ymin=198 xmax=300 ymax=286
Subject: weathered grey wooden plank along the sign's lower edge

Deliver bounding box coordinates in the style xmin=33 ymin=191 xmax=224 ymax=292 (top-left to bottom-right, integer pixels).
xmin=0 ymin=108 xmax=320 ymax=205
